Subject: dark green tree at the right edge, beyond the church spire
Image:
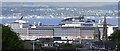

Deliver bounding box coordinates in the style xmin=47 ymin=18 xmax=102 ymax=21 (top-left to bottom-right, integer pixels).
xmin=109 ymin=29 xmax=120 ymax=51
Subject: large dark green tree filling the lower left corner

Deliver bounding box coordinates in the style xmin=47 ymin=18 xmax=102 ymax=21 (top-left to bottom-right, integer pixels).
xmin=2 ymin=26 xmax=25 ymax=51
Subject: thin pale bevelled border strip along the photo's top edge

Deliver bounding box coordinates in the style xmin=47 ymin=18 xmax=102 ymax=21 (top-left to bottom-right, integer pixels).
xmin=0 ymin=0 xmax=120 ymax=2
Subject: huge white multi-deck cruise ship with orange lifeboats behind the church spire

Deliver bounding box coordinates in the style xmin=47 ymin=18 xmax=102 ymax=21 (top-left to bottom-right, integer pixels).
xmin=5 ymin=16 xmax=118 ymax=40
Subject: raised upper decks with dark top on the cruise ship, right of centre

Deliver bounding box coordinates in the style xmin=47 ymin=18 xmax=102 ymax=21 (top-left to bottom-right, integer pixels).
xmin=59 ymin=16 xmax=95 ymax=27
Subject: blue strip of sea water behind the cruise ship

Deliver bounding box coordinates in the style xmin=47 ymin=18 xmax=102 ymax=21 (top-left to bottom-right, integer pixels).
xmin=0 ymin=18 xmax=119 ymax=25
